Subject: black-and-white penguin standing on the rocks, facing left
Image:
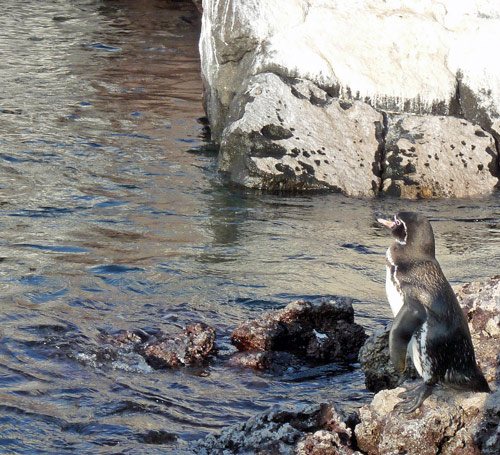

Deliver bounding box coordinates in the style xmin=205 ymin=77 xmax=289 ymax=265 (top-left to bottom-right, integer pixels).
xmin=377 ymin=212 xmax=490 ymax=413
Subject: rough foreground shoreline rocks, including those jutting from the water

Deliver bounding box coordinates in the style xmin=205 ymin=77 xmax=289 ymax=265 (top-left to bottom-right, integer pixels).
xmin=85 ymin=275 xmax=500 ymax=455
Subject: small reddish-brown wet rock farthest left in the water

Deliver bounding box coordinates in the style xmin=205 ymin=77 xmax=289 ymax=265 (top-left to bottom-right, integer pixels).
xmin=140 ymin=323 xmax=215 ymax=368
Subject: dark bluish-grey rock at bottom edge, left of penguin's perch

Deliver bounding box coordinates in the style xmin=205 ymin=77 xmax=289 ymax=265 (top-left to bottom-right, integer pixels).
xmin=193 ymin=403 xmax=359 ymax=455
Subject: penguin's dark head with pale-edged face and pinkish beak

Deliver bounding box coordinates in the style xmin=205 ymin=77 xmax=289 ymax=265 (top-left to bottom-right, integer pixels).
xmin=378 ymin=212 xmax=435 ymax=257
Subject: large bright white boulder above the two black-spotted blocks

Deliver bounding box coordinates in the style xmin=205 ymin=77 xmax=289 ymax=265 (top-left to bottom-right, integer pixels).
xmin=200 ymin=0 xmax=500 ymax=197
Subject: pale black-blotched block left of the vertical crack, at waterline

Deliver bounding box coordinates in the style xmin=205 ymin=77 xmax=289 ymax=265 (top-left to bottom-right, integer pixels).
xmin=218 ymin=73 xmax=383 ymax=196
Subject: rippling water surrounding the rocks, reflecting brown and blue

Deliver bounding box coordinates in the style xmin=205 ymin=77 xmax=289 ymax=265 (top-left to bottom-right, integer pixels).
xmin=0 ymin=0 xmax=500 ymax=454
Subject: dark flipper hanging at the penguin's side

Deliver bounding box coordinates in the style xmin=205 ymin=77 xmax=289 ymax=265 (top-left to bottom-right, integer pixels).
xmin=389 ymin=295 xmax=427 ymax=371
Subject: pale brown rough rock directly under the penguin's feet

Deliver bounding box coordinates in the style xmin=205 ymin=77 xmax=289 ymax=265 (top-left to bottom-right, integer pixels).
xmin=355 ymin=388 xmax=500 ymax=455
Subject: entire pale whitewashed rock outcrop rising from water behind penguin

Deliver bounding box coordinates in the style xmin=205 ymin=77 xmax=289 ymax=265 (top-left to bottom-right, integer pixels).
xmin=200 ymin=0 xmax=500 ymax=198
